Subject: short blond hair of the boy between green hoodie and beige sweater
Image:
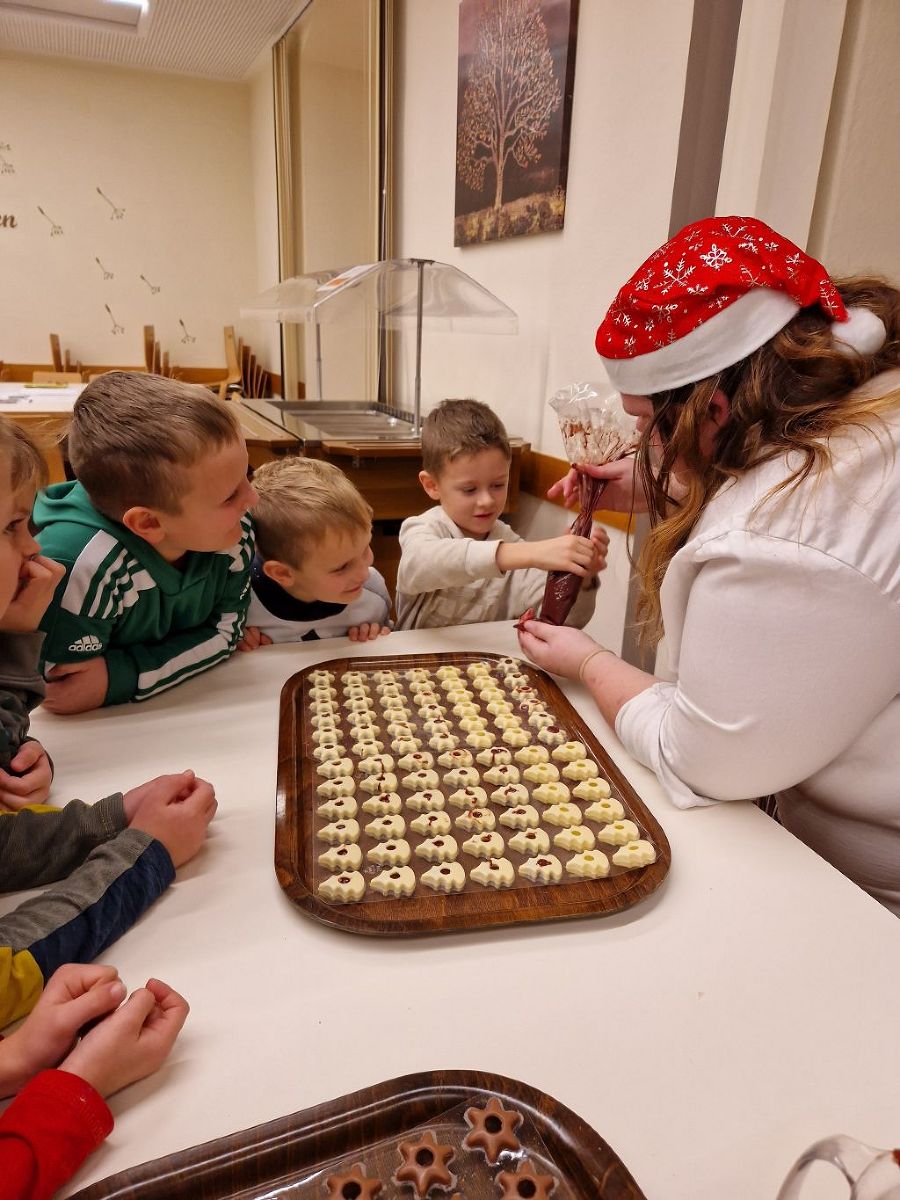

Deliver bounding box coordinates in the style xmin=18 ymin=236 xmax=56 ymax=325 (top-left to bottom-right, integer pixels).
xmin=253 ymin=457 xmax=372 ymax=568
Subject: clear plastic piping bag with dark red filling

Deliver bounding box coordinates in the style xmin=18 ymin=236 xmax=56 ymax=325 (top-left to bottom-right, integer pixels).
xmin=540 ymin=383 xmax=638 ymax=625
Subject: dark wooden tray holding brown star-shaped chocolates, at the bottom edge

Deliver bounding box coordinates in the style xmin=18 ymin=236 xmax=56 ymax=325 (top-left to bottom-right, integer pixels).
xmin=73 ymin=1070 xmax=646 ymax=1200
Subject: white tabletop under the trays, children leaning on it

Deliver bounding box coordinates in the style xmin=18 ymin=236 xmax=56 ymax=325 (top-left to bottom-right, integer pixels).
xmin=0 ymin=623 xmax=900 ymax=1200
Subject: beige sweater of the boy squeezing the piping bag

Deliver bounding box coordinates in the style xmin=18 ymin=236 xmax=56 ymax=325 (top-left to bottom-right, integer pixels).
xmin=397 ymin=505 xmax=596 ymax=629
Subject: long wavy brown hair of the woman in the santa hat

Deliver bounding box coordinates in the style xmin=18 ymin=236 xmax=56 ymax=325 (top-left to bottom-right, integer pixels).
xmin=635 ymin=276 xmax=900 ymax=642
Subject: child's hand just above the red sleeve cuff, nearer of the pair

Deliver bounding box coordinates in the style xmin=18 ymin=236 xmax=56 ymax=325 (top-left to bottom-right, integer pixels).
xmin=60 ymin=979 xmax=190 ymax=1097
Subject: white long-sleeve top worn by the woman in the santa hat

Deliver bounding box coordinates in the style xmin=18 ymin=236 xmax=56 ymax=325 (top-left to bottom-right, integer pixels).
xmin=616 ymin=371 xmax=900 ymax=914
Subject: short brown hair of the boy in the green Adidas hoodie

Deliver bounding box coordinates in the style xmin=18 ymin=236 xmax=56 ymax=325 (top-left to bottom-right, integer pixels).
xmin=68 ymin=371 xmax=242 ymax=521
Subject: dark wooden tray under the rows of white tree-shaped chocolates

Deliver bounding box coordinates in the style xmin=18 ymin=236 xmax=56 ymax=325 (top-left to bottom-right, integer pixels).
xmin=275 ymin=652 xmax=671 ymax=936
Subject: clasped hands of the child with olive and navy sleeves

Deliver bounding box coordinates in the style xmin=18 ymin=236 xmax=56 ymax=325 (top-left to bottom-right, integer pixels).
xmin=125 ymin=770 xmax=218 ymax=868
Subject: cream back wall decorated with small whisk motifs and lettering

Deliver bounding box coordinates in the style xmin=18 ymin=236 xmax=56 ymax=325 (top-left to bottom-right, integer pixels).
xmin=0 ymin=56 xmax=257 ymax=366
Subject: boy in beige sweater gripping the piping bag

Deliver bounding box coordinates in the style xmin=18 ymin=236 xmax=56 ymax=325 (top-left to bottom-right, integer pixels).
xmin=397 ymin=400 xmax=608 ymax=629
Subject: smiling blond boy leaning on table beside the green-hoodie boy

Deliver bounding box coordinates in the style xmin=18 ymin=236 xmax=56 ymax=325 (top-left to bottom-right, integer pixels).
xmin=240 ymin=458 xmax=391 ymax=650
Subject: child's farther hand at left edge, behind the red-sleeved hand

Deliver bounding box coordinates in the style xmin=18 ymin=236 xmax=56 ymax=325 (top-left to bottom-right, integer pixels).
xmin=0 ymin=962 xmax=125 ymax=1096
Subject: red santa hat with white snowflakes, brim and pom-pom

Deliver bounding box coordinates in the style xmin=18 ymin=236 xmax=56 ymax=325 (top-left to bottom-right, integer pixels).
xmin=595 ymin=217 xmax=886 ymax=396
